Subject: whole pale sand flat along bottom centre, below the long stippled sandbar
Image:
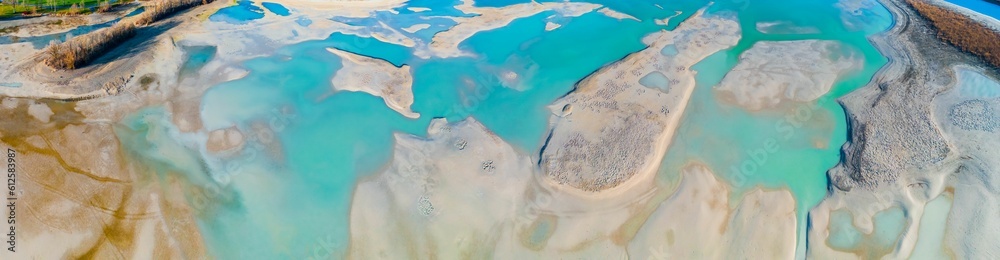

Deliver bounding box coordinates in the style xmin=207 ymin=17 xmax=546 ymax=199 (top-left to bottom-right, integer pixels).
xmin=349 ymin=118 xmax=796 ymax=259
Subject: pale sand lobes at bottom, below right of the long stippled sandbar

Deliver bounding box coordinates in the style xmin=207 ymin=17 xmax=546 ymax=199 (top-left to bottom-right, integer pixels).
xmin=628 ymin=165 xmax=796 ymax=259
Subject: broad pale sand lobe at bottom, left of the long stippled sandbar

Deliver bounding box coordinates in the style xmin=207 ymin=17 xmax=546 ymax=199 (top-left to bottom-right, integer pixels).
xmin=350 ymin=119 xmax=532 ymax=259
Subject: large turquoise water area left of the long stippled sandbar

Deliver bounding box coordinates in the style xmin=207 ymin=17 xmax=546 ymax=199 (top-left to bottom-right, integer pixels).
xmin=123 ymin=2 xmax=688 ymax=259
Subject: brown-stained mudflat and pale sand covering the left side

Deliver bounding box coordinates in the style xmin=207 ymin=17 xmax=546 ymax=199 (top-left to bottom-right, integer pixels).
xmin=0 ymin=1 xmax=432 ymax=259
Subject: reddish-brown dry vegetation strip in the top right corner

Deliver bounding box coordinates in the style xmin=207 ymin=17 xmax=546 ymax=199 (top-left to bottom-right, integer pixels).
xmin=906 ymin=0 xmax=1000 ymax=68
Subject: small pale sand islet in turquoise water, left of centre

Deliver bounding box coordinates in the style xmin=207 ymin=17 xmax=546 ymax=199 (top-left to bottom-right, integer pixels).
xmin=326 ymin=48 xmax=420 ymax=118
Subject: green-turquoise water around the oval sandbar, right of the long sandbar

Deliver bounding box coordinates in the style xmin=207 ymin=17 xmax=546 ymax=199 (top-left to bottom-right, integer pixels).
xmin=660 ymin=0 xmax=892 ymax=258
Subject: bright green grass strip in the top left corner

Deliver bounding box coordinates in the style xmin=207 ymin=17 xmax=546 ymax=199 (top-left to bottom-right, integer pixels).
xmin=0 ymin=0 xmax=122 ymax=18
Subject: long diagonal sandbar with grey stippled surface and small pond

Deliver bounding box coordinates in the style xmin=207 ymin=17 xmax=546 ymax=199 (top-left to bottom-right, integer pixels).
xmin=539 ymin=12 xmax=740 ymax=191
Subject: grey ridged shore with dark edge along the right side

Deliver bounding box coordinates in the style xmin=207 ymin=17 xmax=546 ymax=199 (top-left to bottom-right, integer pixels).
xmin=808 ymin=0 xmax=1000 ymax=259
